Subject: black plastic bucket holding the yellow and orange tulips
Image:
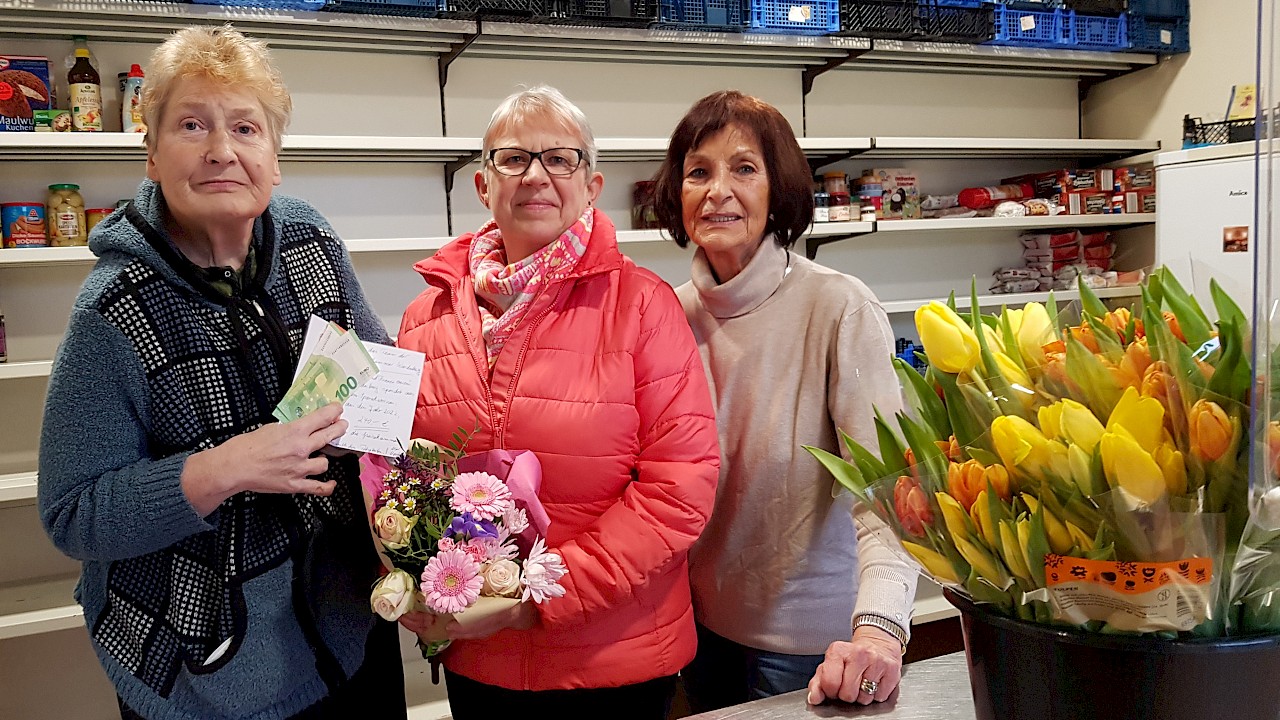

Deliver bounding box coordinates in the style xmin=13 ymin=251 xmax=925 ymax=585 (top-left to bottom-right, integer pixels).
xmin=943 ymin=591 xmax=1280 ymax=720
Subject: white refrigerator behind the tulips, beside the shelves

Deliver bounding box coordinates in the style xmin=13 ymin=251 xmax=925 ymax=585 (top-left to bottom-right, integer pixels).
xmin=1155 ymin=142 xmax=1258 ymax=318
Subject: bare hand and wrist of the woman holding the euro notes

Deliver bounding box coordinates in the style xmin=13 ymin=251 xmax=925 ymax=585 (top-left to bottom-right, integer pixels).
xmin=182 ymin=402 xmax=347 ymax=516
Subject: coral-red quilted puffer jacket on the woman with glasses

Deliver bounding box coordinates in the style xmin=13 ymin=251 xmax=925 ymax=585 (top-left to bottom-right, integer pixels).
xmin=398 ymin=210 xmax=719 ymax=691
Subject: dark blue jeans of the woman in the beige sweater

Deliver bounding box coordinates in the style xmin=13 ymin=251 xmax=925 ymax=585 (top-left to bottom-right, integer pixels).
xmin=680 ymin=625 xmax=823 ymax=714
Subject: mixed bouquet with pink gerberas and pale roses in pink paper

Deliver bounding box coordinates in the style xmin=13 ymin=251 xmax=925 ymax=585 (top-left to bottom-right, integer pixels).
xmin=360 ymin=434 xmax=567 ymax=656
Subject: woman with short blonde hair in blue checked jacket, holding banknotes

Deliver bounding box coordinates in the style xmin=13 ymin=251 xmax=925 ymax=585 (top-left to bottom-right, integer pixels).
xmin=38 ymin=27 xmax=404 ymax=720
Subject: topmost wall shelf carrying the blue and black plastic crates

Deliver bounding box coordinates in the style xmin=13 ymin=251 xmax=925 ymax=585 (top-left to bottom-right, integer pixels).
xmin=0 ymin=0 xmax=1156 ymax=78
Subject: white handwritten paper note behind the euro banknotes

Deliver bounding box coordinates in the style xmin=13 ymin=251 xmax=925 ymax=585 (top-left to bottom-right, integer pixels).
xmin=294 ymin=316 xmax=426 ymax=457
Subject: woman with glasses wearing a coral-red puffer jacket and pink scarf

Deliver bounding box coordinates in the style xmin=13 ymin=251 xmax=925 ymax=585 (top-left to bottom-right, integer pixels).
xmin=398 ymin=87 xmax=719 ymax=720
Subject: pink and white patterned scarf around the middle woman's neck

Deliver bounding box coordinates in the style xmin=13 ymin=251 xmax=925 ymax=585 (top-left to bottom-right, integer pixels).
xmin=471 ymin=206 xmax=595 ymax=369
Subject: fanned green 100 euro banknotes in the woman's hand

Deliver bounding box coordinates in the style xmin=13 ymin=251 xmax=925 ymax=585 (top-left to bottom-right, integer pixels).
xmin=273 ymin=325 xmax=378 ymax=423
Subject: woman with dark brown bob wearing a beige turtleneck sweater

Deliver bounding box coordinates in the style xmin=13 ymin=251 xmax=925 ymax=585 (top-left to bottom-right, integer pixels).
xmin=655 ymin=91 xmax=916 ymax=712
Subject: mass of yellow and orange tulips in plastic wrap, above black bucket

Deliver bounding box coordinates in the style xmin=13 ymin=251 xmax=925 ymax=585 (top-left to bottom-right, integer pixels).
xmin=809 ymin=269 xmax=1280 ymax=635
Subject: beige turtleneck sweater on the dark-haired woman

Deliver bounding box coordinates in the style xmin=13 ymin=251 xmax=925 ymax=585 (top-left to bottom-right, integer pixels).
xmin=676 ymin=238 xmax=916 ymax=655
